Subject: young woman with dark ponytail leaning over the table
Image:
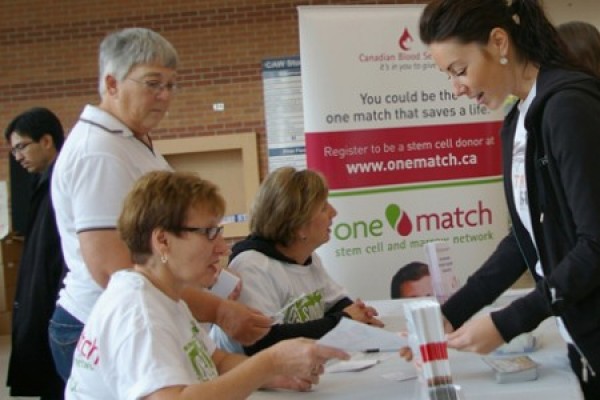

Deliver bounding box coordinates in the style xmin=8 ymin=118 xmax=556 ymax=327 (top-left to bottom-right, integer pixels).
xmin=420 ymin=0 xmax=600 ymax=400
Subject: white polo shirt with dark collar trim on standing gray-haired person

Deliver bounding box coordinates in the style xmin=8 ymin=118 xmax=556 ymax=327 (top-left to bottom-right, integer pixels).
xmin=51 ymin=105 xmax=171 ymax=323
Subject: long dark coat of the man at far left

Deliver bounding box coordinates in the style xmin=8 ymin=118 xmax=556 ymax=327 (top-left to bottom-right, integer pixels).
xmin=7 ymin=165 xmax=64 ymax=398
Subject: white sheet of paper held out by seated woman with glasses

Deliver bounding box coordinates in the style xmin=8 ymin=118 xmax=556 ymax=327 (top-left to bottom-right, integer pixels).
xmin=317 ymin=318 xmax=408 ymax=352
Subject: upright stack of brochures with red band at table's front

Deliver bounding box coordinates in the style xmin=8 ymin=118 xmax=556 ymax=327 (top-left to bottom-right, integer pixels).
xmin=404 ymin=300 xmax=458 ymax=400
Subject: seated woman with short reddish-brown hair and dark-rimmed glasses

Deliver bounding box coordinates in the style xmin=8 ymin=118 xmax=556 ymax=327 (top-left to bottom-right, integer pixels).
xmin=66 ymin=171 xmax=348 ymax=400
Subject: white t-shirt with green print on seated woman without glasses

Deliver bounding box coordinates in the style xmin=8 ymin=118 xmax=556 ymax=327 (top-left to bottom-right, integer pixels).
xmin=210 ymin=250 xmax=348 ymax=352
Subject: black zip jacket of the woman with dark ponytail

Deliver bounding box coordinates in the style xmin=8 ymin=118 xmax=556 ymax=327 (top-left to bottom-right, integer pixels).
xmin=443 ymin=68 xmax=600 ymax=372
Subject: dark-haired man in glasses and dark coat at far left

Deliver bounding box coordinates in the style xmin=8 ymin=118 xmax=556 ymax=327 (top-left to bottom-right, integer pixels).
xmin=4 ymin=107 xmax=64 ymax=400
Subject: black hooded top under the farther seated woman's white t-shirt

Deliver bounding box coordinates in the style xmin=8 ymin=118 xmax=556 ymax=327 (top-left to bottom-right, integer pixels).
xmin=229 ymin=236 xmax=352 ymax=355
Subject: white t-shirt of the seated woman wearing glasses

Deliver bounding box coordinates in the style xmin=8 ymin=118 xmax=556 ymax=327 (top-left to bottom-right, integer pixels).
xmin=65 ymin=270 xmax=218 ymax=400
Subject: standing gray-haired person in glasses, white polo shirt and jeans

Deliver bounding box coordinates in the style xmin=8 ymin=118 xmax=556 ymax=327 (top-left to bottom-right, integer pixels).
xmin=50 ymin=28 xmax=270 ymax=380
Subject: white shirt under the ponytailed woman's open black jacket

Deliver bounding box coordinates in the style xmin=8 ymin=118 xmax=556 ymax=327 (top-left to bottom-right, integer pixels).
xmin=511 ymin=83 xmax=573 ymax=343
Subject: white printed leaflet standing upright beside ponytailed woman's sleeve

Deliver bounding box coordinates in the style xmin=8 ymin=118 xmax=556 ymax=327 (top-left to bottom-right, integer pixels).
xmin=424 ymin=242 xmax=460 ymax=304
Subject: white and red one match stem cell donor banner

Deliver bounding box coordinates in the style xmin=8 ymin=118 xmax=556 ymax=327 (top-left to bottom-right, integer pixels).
xmin=298 ymin=5 xmax=508 ymax=299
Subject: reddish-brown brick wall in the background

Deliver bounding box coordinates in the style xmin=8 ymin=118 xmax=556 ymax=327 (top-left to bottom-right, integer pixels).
xmin=0 ymin=0 xmax=422 ymax=184
